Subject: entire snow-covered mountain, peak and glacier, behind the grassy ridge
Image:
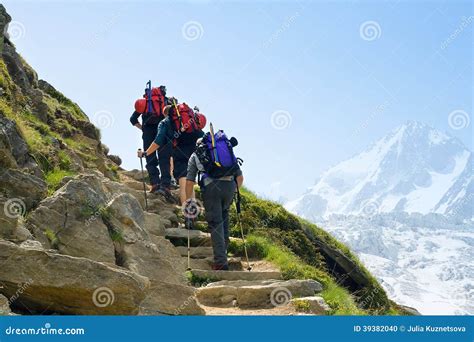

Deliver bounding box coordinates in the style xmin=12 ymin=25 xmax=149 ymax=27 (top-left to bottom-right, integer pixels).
xmin=285 ymin=122 xmax=474 ymax=314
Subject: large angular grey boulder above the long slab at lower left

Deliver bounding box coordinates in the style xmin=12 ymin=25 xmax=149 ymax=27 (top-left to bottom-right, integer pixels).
xmin=28 ymin=179 xmax=116 ymax=264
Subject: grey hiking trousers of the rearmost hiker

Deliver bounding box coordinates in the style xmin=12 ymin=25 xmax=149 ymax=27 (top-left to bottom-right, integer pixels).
xmin=202 ymin=180 xmax=236 ymax=266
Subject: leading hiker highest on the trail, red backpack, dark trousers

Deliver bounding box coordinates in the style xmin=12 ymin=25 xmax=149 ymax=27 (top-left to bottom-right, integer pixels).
xmin=130 ymin=82 xmax=172 ymax=196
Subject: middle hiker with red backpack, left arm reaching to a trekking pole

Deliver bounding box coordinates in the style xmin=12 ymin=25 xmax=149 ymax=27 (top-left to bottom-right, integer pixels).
xmin=138 ymin=101 xmax=206 ymax=204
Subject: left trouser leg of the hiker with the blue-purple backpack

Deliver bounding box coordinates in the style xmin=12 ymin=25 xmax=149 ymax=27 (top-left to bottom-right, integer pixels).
xmin=202 ymin=183 xmax=227 ymax=267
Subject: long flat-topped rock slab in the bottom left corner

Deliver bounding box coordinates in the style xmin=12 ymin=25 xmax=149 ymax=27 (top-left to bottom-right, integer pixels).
xmin=0 ymin=240 xmax=150 ymax=315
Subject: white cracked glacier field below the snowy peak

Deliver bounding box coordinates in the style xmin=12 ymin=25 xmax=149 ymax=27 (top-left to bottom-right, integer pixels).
xmin=319 ymin=213 xmax=474 ymax=315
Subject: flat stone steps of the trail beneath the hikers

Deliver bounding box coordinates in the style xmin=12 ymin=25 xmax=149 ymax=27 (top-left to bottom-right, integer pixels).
xmin=122 ymin=173 xmax=330 ymax=315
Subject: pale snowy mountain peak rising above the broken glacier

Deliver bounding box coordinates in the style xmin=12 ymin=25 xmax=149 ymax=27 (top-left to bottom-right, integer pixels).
xmin=286 ymin=121 xmax=474 ymax=221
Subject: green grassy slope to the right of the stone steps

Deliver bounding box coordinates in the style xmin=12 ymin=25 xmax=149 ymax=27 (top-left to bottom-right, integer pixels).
xmin=226 ymin=190 xmax=404 ymax=314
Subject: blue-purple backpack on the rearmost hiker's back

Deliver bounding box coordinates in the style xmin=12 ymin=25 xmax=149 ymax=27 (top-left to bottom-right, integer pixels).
xmin=196 ymin=130 xmax=241 ymax=179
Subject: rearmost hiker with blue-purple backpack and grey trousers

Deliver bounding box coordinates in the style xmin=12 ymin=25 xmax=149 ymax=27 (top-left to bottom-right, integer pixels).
xmin=184 ymin=124 xmax=244 ymax=270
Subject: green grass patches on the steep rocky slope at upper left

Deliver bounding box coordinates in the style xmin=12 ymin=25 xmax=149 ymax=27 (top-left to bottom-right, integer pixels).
xmin=0 ymin=58 xmax=117 ymax=194
